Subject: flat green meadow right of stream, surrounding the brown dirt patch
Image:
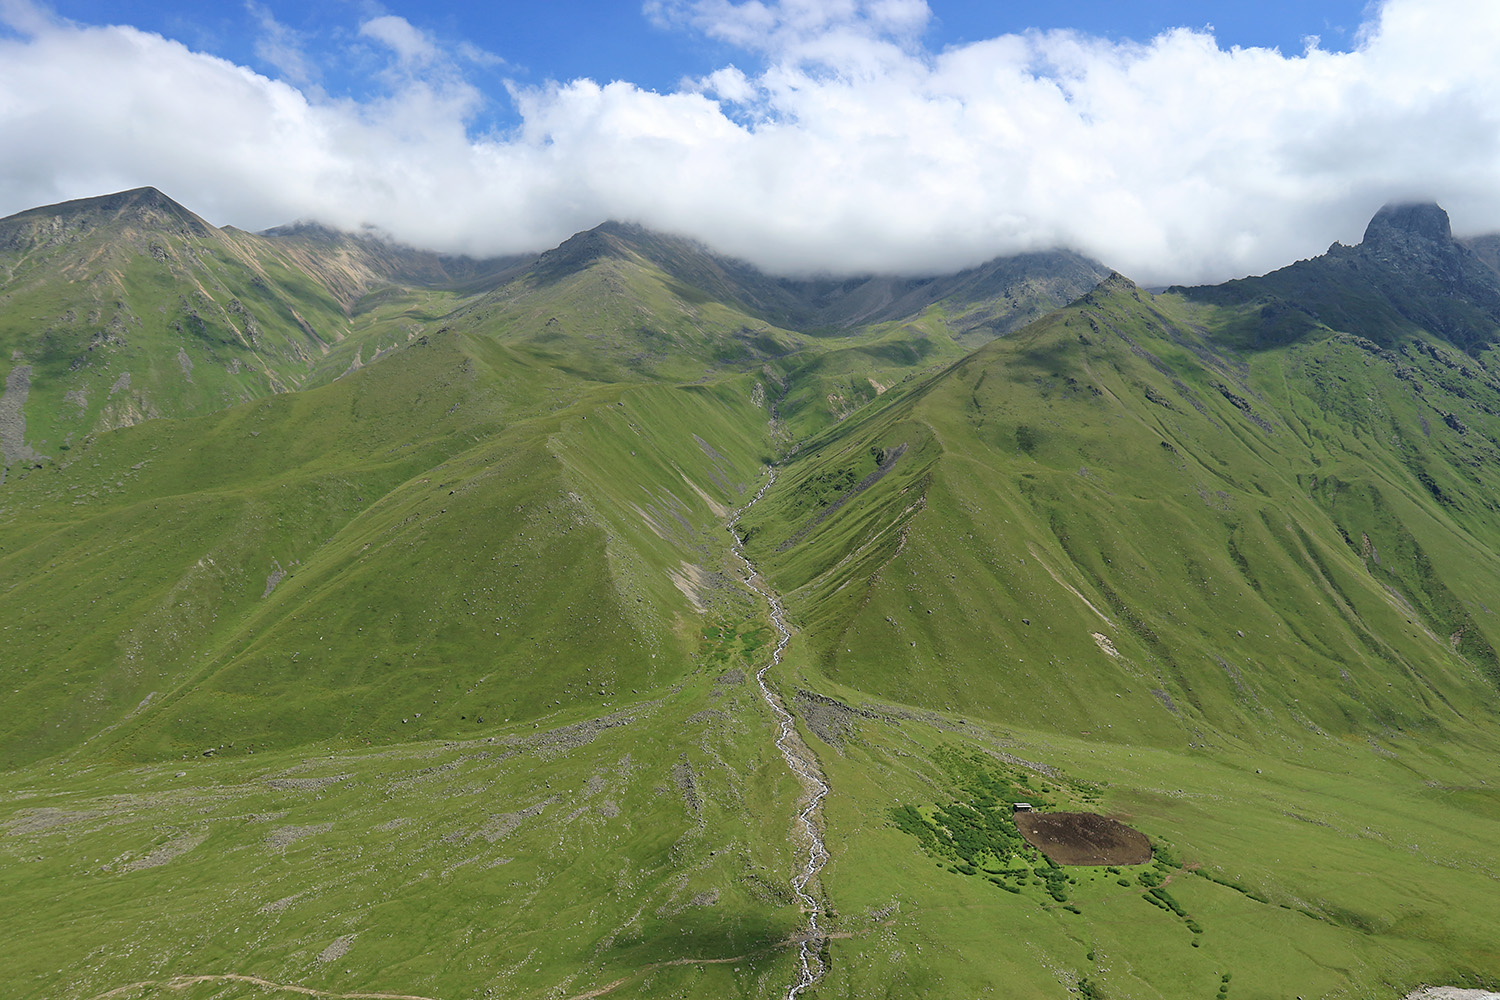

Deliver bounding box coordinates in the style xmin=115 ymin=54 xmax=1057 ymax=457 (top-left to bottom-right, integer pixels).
xmin=821 ymin=680 xmax=1500 ymax=1000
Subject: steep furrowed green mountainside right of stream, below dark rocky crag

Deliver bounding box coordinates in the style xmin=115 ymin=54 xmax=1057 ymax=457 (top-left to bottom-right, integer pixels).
xmin=746 ymin=280 xmax=1500 ymax=755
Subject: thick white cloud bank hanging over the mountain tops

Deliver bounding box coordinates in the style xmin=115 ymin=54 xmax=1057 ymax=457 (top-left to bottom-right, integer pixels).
xmin=0 ymin=0 xmax=1500 ymax=282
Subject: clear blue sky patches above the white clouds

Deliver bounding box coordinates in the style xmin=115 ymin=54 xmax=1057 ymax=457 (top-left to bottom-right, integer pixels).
xmin=35 ymin=0 xmax=1367 ymax=123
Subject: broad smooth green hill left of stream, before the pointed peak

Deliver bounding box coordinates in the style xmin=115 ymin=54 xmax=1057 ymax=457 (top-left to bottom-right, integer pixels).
xmin=0 ymin=316 xmax=765 ymax=762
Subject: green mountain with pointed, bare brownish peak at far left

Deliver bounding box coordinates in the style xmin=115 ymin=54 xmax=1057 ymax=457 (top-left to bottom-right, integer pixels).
xmin=0 ymin=187 xmax=531 ymax=465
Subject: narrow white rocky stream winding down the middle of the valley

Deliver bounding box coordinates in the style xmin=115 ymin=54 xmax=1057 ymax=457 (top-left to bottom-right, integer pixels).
xmin=728 ymin=468 xmax=828 ymax=1000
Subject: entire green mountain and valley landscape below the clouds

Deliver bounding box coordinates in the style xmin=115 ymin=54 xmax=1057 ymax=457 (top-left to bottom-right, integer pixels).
xmin=0 ymin=187 xmax=1500 ymax=1000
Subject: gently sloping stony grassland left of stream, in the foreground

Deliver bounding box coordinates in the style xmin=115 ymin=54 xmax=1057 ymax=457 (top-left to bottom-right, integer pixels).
xmin=0 ymin=670 xmax=822 ymax=1000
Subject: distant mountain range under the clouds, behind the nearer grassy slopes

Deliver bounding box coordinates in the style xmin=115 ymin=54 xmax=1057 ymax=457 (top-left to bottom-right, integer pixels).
xmin=0 ymin=187 xmax=1103 ymax=465
